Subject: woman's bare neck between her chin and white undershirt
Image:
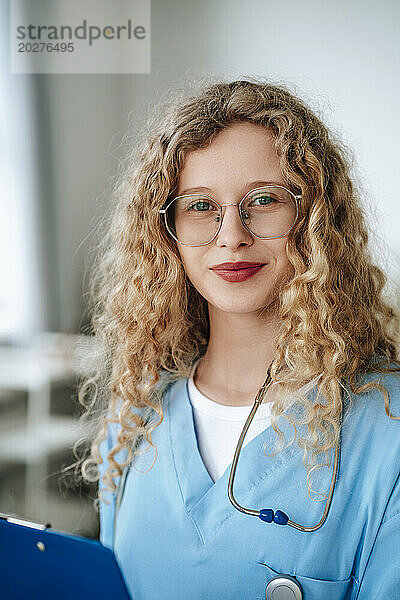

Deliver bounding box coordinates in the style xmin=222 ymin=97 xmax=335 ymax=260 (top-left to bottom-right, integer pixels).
xmin=194 ymin=305 xmax=279 ymax=406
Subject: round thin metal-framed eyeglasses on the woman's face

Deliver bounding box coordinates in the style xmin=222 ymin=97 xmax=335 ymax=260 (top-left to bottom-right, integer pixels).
xmin=160 ymin=185 xmax=301 ymax=246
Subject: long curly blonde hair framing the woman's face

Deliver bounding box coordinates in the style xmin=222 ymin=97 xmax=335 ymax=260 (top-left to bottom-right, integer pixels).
xmin=75 ymin=78 xmax=399 ymax=503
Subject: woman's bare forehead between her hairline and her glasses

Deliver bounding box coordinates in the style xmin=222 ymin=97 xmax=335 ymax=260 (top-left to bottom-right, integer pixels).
xmin=179 ymin=122 xmax=284 ymax=190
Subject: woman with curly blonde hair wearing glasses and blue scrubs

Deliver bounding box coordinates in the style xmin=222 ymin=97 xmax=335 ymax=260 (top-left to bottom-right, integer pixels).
xmin=81 ymin=80 xmax=400 ymax=600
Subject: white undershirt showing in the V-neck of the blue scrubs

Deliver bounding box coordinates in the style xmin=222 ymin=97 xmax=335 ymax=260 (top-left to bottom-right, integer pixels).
xmin=188 ymin=360 xmax=319 ymax=482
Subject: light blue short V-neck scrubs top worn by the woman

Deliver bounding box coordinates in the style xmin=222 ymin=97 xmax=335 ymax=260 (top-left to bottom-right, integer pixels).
xmin=100 ymin=374 xmax=400 ymax=600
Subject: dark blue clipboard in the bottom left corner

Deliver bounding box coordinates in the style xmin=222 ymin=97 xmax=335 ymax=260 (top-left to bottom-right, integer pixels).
xmin=0 ymin=513 xmax=132 ymax=600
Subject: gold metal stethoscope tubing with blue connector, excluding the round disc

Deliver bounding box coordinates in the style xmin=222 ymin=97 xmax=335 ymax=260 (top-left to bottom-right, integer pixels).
xmin=228 ymin=368 xmax=340 ymax=531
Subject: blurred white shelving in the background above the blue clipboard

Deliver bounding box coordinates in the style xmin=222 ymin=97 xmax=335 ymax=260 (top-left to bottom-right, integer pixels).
xmin=0 ymin=332 xmax=99 ymax=537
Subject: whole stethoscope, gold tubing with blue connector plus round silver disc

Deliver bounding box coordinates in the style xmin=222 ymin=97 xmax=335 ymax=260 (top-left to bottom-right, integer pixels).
xmin=228 ymin=367 xmax=340 ymax=600
